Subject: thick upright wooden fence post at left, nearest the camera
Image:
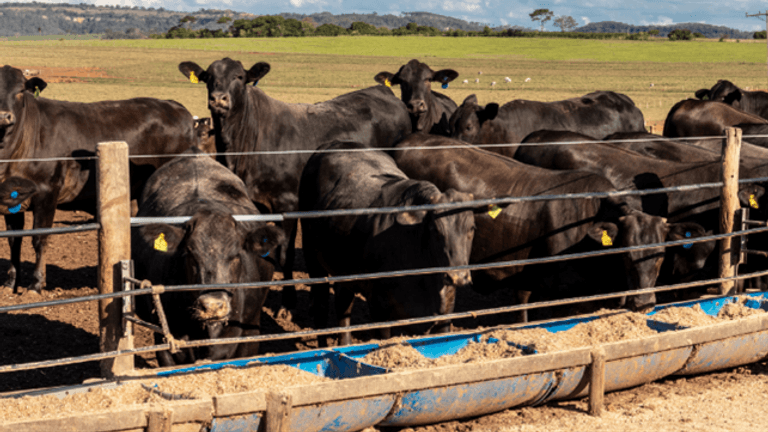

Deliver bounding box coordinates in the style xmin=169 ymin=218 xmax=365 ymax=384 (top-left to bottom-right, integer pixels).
xmin=96 ymin=142 xmax=133 ymax=378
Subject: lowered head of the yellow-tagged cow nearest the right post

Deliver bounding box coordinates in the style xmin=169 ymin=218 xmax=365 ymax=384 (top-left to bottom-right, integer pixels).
xmin=588 ymin=210 xmax=712 ymax=310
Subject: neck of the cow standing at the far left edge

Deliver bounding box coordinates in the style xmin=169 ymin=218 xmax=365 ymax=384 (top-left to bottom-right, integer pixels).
xmin=0 ymin=92 xmax=41 ymax=176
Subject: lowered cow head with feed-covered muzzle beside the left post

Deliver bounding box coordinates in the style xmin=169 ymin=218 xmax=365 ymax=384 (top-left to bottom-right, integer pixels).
xmin=140 ymin=209 xmax=285 ymax=338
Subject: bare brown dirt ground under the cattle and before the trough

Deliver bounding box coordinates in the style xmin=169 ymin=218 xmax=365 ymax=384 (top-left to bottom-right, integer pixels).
xmin=0 ymin=211 xmax=768 ymax=432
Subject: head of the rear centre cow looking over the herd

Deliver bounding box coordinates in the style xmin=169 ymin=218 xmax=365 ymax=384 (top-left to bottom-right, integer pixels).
xmin=374 ymin=59 xmax=459 ymax=132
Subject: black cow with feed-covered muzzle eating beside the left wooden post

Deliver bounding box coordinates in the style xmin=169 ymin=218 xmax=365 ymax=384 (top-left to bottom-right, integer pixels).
xmin=131 ymin=148 xmax=285 ymax=366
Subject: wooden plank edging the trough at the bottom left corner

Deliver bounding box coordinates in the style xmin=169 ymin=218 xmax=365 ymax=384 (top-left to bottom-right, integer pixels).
xmin=0 ymin=407 xmax=147 ymax=432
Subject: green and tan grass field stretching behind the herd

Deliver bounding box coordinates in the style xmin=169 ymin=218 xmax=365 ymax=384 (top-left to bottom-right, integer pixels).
xmin=0 ymin=37 xmax=768 ymax=122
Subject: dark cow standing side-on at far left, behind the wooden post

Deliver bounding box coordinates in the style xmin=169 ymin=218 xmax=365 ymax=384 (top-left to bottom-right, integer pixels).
xmin=0 ymin=66 xmax=197 ymax=292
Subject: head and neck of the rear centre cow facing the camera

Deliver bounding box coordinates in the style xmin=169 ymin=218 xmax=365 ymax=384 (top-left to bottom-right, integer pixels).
xmin=374 ymin=59 xmax=459 ymax=136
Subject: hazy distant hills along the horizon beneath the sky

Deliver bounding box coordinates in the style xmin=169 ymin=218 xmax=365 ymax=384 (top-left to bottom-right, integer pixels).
xmin=0 ymin=3 xmax=752 ymax=39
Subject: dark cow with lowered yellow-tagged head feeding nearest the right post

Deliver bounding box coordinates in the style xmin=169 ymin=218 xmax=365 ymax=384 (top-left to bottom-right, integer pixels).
xmin=392 ymin=134 xmax=682 ymax=319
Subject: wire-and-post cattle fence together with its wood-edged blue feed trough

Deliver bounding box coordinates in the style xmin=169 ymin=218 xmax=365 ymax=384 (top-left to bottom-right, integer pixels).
xmin=0 ymin=130 xmax=768 ymax=431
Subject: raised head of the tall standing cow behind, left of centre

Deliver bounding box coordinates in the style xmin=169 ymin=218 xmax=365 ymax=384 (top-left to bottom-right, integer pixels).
xmin=179 ymin=57 xmax=269 ymax=118
